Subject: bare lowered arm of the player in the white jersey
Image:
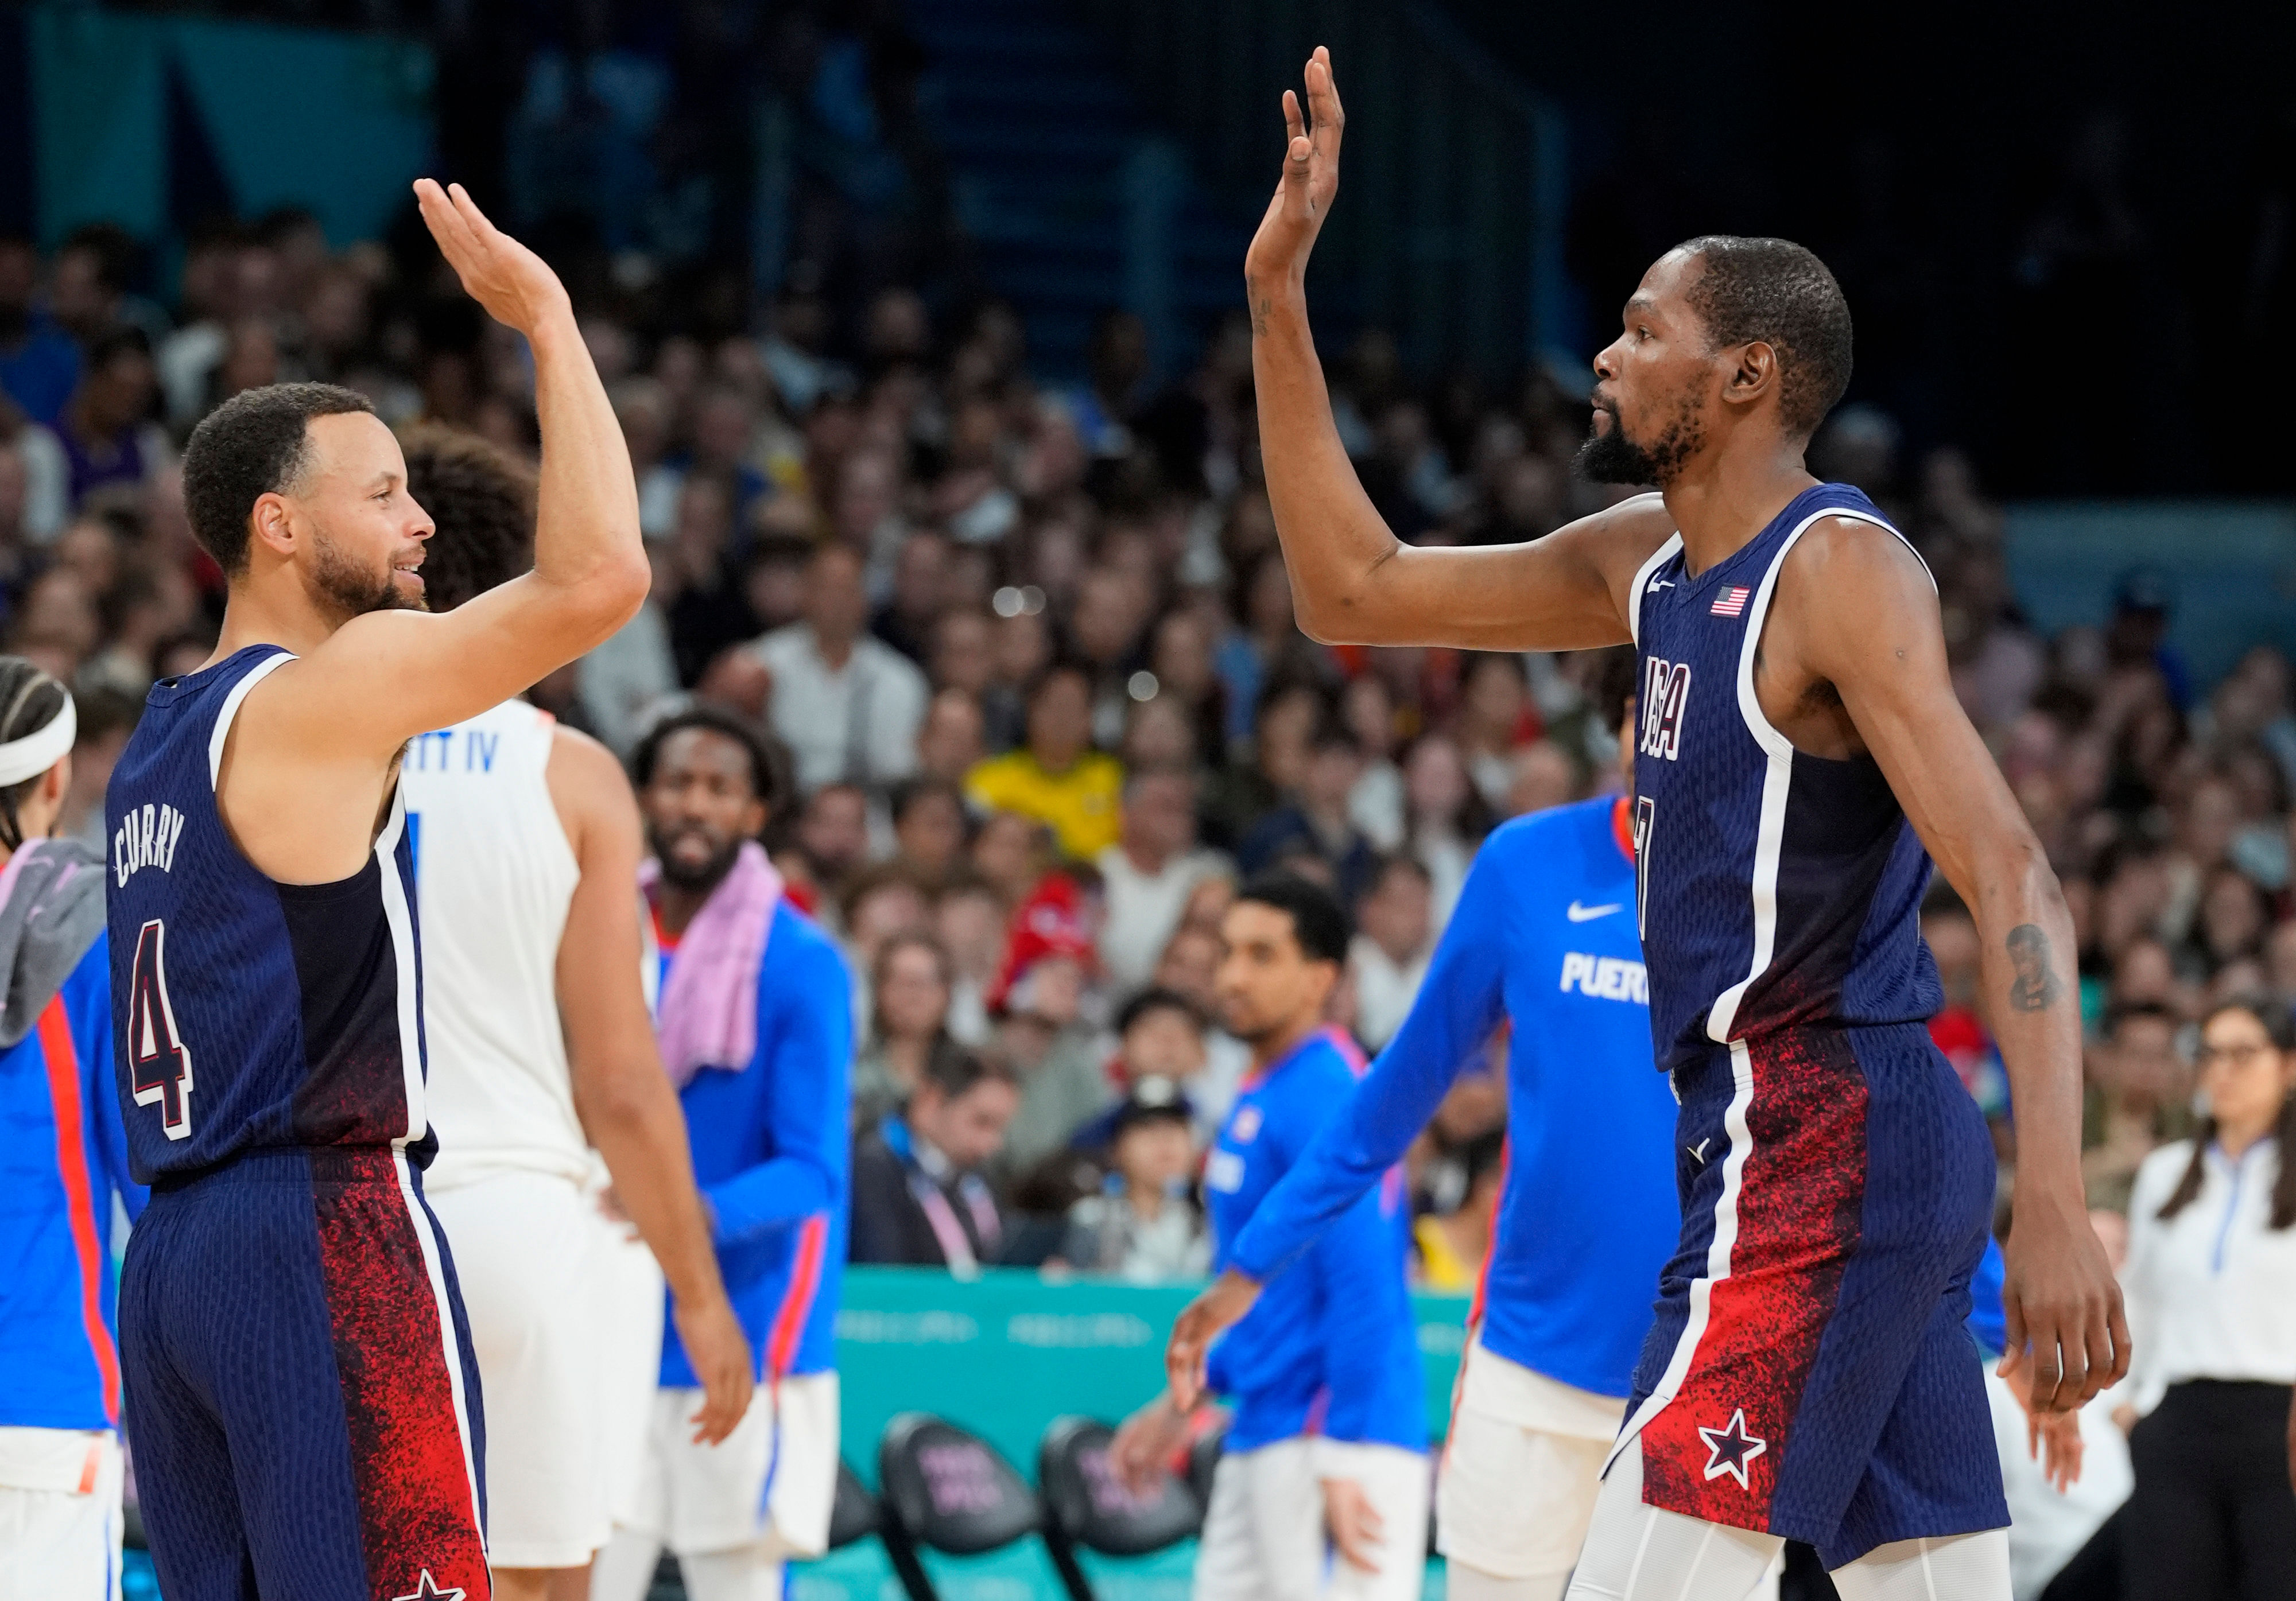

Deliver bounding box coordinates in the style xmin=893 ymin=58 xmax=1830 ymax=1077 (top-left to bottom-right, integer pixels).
xmin=546 ymin=729 xmax=753 ymax=1443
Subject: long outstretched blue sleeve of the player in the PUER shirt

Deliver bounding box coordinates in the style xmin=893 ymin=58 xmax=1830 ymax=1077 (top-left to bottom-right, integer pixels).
xmin=1228 ymin=837 xmax=1506 ymax=1284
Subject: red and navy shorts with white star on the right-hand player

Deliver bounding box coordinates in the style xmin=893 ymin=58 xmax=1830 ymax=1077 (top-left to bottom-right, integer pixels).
xmin=1619 ymin=1025 xmax=2009 ymax=1567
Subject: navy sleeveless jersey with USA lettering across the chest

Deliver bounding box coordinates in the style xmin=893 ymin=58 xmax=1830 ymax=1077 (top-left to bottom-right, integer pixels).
xmin=1628 ymin=484 xmax=1942 ymax=1071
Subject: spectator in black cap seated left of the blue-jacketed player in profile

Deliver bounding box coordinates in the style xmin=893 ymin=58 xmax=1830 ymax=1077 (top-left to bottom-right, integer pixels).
xmin=1061 ymin=1078 xmax=1212 ymax=1284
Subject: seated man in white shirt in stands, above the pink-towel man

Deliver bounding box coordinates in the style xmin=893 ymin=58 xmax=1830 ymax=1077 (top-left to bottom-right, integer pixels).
xmin=751 ymin=543 xmax=925 ymax=794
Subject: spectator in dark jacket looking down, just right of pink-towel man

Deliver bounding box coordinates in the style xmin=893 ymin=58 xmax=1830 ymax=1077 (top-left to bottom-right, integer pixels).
xmin=850 ymin=1051 xmax=1019 ymax=1273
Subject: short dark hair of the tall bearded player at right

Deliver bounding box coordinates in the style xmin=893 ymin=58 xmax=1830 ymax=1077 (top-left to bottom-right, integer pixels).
xmin=1676 ymin=234 xmax=1851 ymax=438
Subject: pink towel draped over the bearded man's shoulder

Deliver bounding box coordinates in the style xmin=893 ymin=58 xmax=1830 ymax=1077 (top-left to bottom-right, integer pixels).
xmin=638 ymin=840 xmax=781 ymax=1090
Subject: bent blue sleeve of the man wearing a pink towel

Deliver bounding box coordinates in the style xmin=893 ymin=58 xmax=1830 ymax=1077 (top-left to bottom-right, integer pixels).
xmin=703 ymin=929 xmax=854 ymax=1248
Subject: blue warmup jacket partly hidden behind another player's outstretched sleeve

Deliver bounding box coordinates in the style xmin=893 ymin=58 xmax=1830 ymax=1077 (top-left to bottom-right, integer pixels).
xmin=1203 ymin=1030 xmax=1428 ymax=1452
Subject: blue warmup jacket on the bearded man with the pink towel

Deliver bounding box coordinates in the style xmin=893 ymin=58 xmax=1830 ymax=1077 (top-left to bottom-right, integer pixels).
xmin=661 ymin=901 xmax=854 ymax=1388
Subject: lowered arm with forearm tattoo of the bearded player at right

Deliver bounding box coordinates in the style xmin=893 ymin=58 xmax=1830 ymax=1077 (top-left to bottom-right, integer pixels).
xmin=1766 ymin=523 xmax=2128 ymax=1413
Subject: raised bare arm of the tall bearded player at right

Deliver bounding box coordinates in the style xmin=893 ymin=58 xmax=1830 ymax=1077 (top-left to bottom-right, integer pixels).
xmin=1244 ymin=46 xmax=1674 ymax=651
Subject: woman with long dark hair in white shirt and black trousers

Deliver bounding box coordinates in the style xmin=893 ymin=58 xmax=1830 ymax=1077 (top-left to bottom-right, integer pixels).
xmin=2122 ymin=1000 xmax=2296 ymax=1601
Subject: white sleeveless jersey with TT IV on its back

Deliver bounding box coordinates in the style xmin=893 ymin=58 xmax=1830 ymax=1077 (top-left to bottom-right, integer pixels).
xmin=400 ymin=700 xmax=590 ymax=1188
